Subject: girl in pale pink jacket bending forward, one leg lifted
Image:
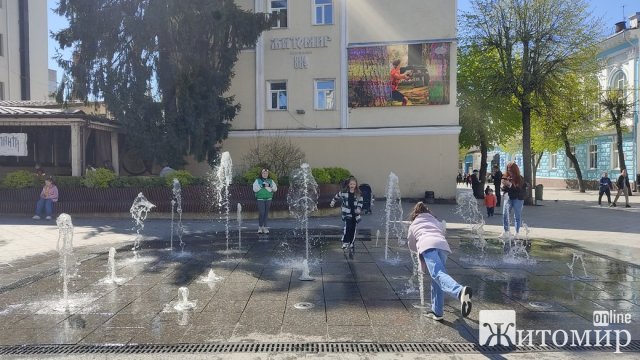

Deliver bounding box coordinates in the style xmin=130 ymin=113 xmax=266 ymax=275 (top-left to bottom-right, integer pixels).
xmin=407 ymin=201 xmax=472 ymax=321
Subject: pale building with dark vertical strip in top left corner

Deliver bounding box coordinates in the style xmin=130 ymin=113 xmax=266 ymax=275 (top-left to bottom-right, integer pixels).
xmin=0 ymin=0 xmax=48 ymax=100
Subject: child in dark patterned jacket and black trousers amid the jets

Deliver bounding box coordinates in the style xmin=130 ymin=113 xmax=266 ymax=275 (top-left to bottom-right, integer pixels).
xmin=329 ymin=176 xmax=362 ymax=249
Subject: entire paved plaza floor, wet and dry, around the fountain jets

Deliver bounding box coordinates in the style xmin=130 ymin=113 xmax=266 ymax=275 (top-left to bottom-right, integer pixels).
xmin=0 ymin=186 xmax=640 ymax=358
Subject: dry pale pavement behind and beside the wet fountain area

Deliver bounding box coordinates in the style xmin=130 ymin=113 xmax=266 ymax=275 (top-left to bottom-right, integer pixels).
xmin=0 ymin=186 xmax=640 ymax=268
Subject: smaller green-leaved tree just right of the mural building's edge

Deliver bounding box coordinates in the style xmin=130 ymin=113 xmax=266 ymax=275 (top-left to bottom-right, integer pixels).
xmin=458 ymin=44 xmax=518 ymax=188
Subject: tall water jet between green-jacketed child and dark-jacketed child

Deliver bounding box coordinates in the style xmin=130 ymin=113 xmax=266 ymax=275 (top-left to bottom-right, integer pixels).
xmin=287 ymin=163 xmax=318 ymax=281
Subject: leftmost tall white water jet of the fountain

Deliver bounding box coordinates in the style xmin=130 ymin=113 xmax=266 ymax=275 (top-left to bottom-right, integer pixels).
xmin=56 ymin=213 xmax=76 ymax=309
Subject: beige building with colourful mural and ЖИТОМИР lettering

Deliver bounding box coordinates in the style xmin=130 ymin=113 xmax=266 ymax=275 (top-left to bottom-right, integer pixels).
xmin=189 ymin=0 xmax=460 ymax=199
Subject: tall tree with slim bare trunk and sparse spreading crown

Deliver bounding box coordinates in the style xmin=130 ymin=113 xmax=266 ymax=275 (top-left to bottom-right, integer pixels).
xmin=463 ymin=0 xmax=599 ymax=203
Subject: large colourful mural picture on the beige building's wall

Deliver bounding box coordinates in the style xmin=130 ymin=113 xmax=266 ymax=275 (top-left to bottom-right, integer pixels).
xmin=348 ymin=42 xmax=451 ymax=107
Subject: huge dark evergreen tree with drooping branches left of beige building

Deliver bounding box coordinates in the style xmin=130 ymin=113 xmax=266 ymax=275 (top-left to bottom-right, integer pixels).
xmin=53 ymin=0 xmax=269 ymax=164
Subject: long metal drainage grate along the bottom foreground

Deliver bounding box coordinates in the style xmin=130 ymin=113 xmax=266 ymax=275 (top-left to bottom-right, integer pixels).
xmin=0 ymin=340 xmax=640 ymax=355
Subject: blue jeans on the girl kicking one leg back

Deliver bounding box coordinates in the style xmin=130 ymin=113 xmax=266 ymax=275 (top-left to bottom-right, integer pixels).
xmin=422 ymin=249 xmax=462 ymax=316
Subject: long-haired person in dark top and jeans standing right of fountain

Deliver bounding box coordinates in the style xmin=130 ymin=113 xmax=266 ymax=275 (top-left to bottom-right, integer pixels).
xmin=500 ymin=161 xmax=527 ymax=239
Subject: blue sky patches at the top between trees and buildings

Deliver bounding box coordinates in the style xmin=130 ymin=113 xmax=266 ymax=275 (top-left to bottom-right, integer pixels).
xmin=47 ymin=0 xmax=640 ymax=80
